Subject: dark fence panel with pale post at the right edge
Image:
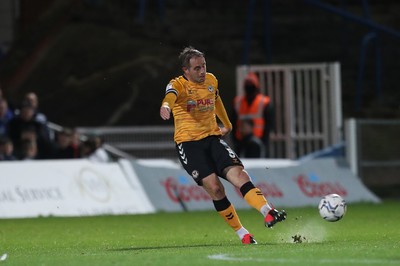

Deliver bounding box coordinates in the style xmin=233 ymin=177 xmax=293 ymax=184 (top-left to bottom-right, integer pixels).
xmin=345 ymin=119 xmax=400 ymax=188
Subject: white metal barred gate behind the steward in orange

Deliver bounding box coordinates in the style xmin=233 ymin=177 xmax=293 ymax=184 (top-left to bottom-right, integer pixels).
xmin=236 ymin=63 xmax=342 ymax=159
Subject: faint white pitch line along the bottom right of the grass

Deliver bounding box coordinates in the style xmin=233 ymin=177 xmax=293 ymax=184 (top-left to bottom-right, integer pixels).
xmin=207 ymin=254 xmax=400 ymax=265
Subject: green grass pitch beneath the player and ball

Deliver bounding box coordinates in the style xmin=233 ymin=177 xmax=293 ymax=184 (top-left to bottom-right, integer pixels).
xmin=0 ymin=202 xmax=400 ymax=266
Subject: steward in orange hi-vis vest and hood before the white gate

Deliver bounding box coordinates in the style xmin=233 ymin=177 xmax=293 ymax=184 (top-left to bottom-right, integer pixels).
xmin=232 ymin=72 xmax=274 ymax=158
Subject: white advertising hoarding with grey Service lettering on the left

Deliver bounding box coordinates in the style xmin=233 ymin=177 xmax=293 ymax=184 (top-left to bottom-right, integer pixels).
xmin=0 ymin=160 xmax=154 ymax=218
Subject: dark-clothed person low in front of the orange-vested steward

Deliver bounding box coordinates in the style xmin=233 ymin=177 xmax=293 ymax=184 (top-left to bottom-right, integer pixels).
xmin=237 ymin=119 xmax=265 ymax=158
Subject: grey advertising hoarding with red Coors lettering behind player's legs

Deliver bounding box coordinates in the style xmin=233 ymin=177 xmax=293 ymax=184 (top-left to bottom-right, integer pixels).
xmin=131 ymin=158 xmax=380 ymax=211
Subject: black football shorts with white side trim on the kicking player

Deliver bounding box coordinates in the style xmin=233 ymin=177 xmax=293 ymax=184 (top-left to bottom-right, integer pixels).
xmin=176 ymin=136 xmax=243 ymax=186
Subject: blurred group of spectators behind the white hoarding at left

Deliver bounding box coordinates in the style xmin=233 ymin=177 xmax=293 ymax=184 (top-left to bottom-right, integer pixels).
xmin=0 ymin=90 xmax=109 ymax=162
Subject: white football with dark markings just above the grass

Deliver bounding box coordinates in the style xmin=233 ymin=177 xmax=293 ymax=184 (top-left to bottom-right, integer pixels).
xmin=318 ymin=194 xmax=347 ymax=222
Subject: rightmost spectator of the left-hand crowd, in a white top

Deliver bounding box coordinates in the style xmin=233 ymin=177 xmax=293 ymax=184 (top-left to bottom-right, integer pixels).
xmin=81 ymin=137 xmax=111 ymax=163
